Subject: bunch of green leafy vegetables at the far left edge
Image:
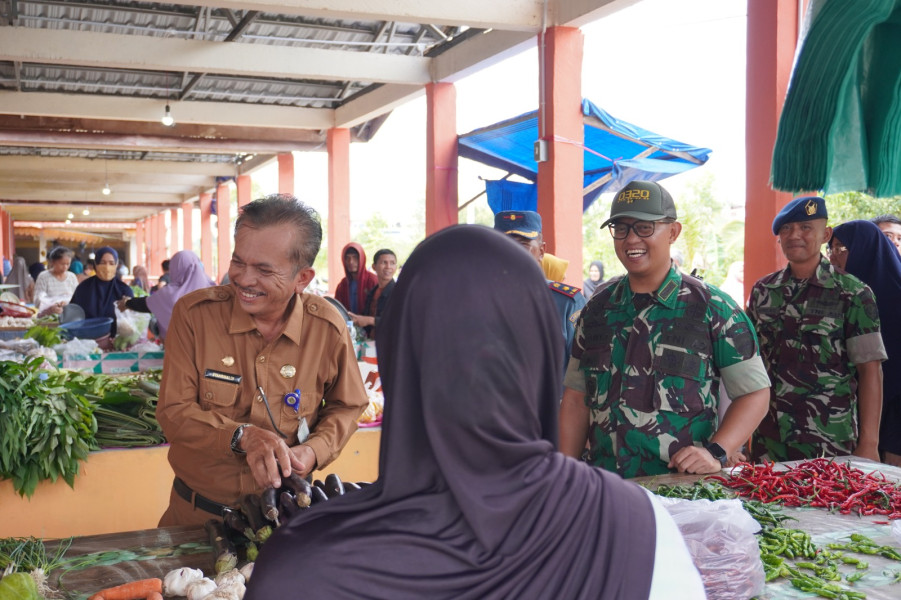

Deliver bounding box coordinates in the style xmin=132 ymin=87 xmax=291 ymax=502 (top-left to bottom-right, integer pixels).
xmin=0 ymin=357 xmax=97 ymax=497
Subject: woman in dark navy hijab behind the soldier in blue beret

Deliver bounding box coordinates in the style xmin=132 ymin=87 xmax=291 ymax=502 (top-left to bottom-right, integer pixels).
xmin=829 ymin=221 xmax=901 ymax=466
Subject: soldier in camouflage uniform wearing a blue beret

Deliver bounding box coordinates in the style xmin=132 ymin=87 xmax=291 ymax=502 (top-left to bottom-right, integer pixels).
xmin=748 ymin=197 xmax=887 ymax=461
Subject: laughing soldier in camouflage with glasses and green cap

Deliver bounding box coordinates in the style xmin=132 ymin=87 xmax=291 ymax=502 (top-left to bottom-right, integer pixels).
xmin=560 ymin=181 xmax=769 ymax=477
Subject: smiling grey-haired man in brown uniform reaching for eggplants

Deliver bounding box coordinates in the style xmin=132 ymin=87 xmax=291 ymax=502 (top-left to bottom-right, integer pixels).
xmin=157 ymin=195 xmax=368 ymax=526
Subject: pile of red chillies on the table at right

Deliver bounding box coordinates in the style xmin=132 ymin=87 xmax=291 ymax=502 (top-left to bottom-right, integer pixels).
xmin=709 ymin=458 xmax=901 ymax=519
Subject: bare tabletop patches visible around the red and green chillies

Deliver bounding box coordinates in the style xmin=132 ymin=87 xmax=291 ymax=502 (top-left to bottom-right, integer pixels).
xmin=633 ymin=456 xmax=901 ymax=600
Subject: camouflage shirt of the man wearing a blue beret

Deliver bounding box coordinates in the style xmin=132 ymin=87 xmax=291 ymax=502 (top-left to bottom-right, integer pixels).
xmin=748 ymin=257 xmax=886 ymax=461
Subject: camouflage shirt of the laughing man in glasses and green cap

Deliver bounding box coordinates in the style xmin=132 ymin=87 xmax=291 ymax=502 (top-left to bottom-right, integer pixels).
xmin=565 ymin=268 xmax=769 ymax=477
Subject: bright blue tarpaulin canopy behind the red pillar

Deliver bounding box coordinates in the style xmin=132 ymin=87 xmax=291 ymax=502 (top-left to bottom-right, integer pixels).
xmin=458 ymin=100 xmax=711 ymax=212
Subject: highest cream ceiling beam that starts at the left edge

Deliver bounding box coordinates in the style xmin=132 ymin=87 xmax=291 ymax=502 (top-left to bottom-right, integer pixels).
xmin=0 ymin=27 xmax=429 ymax=85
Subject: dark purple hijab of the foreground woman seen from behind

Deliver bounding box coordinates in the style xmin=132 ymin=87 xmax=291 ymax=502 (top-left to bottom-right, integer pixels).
xmin=245 ymin=225 xmax=656 ymax=600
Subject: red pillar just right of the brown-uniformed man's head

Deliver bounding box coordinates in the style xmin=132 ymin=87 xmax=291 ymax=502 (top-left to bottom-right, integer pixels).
xmin=325 ymin=128 xmax=350 ymax=294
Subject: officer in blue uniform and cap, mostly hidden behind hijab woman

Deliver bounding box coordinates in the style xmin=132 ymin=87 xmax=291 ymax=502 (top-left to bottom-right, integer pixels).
xmin=494 ymin=210 xmax=585 ymax=371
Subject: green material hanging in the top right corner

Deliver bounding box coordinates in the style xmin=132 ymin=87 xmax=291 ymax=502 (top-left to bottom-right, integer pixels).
xmin=771 ymin=0 xmax=901 ymax=196
